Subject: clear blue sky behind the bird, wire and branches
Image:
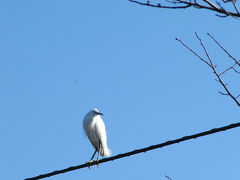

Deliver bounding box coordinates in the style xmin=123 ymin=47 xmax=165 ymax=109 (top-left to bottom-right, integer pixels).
xmin=0 ymin=0 xmax=240 ymax=180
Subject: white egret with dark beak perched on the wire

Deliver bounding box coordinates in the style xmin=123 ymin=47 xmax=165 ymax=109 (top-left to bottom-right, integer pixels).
xmin=83 ymin=109 xmax=111 ymax=162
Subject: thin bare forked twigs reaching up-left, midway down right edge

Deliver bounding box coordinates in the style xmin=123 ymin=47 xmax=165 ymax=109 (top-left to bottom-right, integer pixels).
xmin=176 ymin=33 xmax=240 ymax=106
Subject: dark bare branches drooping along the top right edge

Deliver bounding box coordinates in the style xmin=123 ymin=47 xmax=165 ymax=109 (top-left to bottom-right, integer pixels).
xmin=128 ymin=0 xmax=240 ymax=18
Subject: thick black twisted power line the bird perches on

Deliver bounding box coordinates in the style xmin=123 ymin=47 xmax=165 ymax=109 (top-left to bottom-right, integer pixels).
xmin=25 ymin=122 xmax=240 ymax=180
